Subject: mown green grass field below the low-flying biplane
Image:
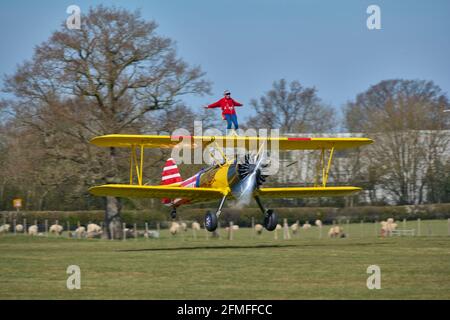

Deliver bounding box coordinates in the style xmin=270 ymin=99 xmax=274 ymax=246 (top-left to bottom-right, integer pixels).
xmin=0 ymin=220 xmax=450 ymax=299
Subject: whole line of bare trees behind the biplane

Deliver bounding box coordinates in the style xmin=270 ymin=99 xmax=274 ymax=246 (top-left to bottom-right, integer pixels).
xmin=0 ymin=6 xmax=450 ymax=235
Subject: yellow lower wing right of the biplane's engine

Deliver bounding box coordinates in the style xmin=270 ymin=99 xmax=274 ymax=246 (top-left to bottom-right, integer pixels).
xmin=257 ymin=187 xmax=361 ymax=198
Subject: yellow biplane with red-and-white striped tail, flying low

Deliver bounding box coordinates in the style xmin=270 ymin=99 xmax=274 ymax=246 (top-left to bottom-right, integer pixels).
xmin=89 ymin=134 xmax=373 ymax=231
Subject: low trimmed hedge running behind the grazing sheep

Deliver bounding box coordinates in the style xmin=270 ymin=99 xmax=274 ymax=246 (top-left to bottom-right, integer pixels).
xmin=0 ymin=203 xmax=450 ymax=228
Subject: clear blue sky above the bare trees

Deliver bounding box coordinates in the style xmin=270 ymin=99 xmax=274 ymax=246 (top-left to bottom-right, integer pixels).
xmin=0 ymin=0 xmax=450 ymax=124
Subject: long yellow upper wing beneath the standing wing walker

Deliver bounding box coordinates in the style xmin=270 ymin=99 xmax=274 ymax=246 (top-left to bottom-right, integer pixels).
xmin=91 ymin=134 xmax=373 ymax=150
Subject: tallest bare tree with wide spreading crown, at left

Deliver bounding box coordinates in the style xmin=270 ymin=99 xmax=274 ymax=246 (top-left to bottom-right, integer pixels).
xmin=4 ymin=6 xmax=209 ymax=238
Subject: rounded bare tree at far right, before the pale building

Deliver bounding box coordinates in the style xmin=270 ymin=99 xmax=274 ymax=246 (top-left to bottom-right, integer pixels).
xmin=345 ymin=80 xmax=449 ymax=204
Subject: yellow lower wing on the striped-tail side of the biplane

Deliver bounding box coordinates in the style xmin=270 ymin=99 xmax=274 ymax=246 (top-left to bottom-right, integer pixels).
xmin=89 ymin=184 xmax=226 ymax=201
